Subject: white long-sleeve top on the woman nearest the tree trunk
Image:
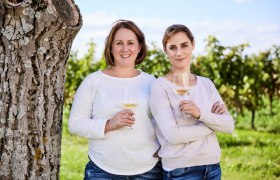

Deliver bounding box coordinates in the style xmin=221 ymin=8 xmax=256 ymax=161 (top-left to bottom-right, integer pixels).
xmin=68 ymin=71 xmax=159 ymax=175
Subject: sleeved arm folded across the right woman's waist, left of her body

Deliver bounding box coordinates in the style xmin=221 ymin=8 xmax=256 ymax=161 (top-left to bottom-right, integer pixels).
xmin=150 ymin=81 xmax=213 ymax=144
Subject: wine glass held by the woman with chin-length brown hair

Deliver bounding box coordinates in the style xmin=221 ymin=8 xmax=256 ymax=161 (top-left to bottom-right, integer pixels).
xmin=121 ymin=87 xmax=137 ymax=130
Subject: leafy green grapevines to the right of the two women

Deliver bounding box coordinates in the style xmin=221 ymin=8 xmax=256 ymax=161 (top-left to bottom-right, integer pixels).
xmin=191 ymin=36 xmax=280 ymax=128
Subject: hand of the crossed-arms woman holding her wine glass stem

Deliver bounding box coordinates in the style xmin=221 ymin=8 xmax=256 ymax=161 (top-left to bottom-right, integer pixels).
xmin=179 ymin=100 xmax=200 ymax=119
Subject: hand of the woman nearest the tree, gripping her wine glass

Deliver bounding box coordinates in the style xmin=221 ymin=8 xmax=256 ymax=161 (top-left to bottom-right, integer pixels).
xmin=105 ymin=109 xmax=135 ymax=133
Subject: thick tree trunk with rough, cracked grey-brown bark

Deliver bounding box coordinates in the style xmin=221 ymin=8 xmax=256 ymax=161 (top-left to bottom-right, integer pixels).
xmin=0 ymin=0 xmax=82 ymax=180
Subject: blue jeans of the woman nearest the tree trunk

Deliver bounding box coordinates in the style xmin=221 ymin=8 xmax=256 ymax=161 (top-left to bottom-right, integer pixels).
xmin=84 ymin=160 xmax=162 ymax=180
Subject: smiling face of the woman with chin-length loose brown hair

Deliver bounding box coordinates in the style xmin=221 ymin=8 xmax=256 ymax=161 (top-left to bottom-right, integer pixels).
xmin=111 ymin=28 xmax=141 ymax=67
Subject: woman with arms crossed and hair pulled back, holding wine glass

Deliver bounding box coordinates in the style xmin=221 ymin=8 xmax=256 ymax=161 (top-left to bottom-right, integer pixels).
xmin=150 ymin=24 xmax=234 ymax=180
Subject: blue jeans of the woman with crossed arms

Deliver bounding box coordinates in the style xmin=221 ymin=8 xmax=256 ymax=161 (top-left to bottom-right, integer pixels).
xmin=163 ymin=163 xmax=222 ymax=180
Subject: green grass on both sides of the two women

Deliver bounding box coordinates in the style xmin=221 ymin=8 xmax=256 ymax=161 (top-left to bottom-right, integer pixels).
xmin=60 ymin=101 xmax=280 ymax=180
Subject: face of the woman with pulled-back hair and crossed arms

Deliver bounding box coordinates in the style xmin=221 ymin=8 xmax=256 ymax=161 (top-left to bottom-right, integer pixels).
xmin=165 ymin=32 xmax=194 ymax=72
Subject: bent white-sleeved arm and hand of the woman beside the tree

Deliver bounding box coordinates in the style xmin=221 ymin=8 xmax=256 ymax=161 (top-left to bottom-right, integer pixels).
xmin=68 ymin=75 xmax=135 ymax=139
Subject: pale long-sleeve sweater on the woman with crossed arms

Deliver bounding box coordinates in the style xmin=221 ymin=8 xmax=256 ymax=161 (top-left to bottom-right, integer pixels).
xmin=150 ymin=76 xmax=234 ymax=171
